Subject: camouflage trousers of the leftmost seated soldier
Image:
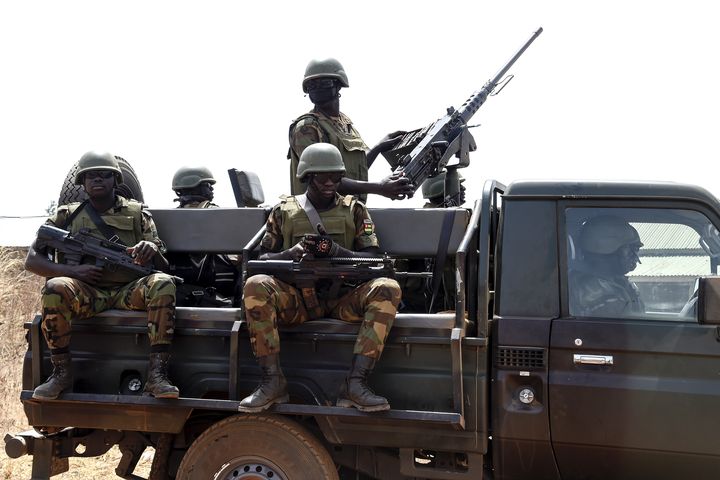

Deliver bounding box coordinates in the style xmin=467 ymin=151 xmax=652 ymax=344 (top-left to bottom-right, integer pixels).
xmin=42 ymin=273 xmax=175 ymax=349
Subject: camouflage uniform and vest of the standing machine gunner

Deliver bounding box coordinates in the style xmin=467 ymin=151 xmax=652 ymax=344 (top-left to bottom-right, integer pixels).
xmin=288 ymin=109 xmax=369 ymax=202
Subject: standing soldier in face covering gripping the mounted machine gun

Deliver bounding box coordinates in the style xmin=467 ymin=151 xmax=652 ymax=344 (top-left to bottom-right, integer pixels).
xmin=288 ymin=58 xmax=413 ymax=202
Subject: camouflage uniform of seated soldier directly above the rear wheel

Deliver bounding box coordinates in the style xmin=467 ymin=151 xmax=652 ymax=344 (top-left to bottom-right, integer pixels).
xmin=244 ymin=195 xmax=401 ymax=359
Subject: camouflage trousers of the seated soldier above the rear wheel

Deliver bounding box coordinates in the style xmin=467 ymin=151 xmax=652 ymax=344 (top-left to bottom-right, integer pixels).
xmin=243 ymin=275 xmax=401 ymax=359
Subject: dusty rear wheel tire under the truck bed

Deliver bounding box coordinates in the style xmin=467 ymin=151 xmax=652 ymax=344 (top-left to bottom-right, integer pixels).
xmin=176 ymin=415 xmax=338 ymax=480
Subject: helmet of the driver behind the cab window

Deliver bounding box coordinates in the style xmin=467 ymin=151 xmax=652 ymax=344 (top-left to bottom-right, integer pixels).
xmin=580 ymin=216 xmax=643 ymax=255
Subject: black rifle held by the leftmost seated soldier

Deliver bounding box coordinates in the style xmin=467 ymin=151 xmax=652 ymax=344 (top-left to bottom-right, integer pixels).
xmin=37 ymin=225 xmax=167 ymax=283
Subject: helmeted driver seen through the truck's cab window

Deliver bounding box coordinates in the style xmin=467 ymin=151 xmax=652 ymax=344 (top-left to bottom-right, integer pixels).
xmin=569 ymin=216 xmax=645 ymax=317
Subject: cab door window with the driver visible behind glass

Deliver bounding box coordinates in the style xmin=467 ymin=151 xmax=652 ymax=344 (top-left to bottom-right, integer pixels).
xmin=565 ymin=208 xmax=720 ymax=321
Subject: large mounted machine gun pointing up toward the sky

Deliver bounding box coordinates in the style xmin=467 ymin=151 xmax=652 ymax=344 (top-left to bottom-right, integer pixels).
xmin=383 ymin=28 xmax=543 ymax=197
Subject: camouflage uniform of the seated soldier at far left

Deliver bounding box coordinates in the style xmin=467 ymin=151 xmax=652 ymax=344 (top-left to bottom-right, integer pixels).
xmin=42 ymin=196 xmax=175 ymax=350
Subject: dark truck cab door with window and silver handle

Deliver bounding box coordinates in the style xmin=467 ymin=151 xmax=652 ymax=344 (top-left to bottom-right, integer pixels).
xmin=549 ymin=202 xmax=720 ymax=480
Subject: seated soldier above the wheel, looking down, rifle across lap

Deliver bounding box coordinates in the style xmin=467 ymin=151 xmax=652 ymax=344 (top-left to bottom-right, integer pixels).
xmin=239 ymin=143 xmax=401 ymax=412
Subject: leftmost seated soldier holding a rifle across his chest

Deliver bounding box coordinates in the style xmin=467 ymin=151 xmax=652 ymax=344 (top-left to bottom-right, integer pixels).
xmin=25 ymin=152 xmax=179 ymax=400
